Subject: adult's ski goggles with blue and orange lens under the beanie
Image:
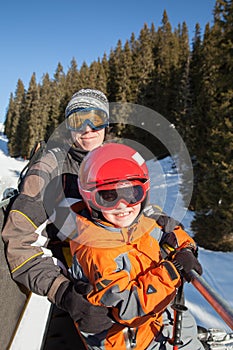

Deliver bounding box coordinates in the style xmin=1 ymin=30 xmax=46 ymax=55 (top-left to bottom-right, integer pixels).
xmin=66 ymin=108 xmax=108 ymax=131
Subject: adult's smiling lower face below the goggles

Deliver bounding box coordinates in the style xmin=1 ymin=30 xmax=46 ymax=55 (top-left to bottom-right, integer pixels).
xmin=71 ymin=125 xmax=105 ymax=151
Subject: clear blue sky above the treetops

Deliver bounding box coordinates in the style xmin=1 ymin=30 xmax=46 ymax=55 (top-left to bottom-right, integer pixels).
xmin=0 ymin=0 xmax=215 ymax=122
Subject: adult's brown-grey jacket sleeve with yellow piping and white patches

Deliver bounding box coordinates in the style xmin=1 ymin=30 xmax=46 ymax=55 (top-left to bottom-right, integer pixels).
xmin=2 ymin=154 xmax=70 ymax=299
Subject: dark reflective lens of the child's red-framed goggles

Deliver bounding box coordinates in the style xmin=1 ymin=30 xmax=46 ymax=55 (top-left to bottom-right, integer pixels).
xmin=95 ymin=184 xmax=145 ymax=209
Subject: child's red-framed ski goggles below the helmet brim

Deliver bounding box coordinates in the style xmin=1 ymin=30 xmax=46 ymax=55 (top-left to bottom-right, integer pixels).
xmin=84 ymin=180 xmax=148 ymax=210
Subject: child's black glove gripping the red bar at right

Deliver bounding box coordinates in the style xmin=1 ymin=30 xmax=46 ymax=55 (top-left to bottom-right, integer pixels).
xmin=172 ymin=248 xmax=202 ymax=282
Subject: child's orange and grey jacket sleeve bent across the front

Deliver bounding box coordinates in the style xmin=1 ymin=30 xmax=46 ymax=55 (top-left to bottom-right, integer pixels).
xmin=76 ymin=248 xmax=180 ymax=324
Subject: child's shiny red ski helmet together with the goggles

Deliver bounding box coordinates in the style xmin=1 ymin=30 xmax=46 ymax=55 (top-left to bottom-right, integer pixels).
xmin=78 ymin=143 xmax=150 ymax=213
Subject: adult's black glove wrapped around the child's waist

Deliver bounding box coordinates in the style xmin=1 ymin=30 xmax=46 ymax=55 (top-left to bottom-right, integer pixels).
xmin=55 ymin=281 xmax=113 ymax=333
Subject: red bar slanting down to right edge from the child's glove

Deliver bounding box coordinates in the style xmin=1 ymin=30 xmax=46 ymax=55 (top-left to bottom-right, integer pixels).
xmin=189 ymin=270 xmax=233 ymax=330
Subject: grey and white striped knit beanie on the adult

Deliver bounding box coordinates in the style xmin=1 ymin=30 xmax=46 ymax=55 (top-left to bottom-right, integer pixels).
xmin=65 ymin=89 xmax=109 ymax=118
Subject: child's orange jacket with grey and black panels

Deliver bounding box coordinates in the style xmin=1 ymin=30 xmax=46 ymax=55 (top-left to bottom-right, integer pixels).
xmin=70 ymin=209 xmax=195 ymax=349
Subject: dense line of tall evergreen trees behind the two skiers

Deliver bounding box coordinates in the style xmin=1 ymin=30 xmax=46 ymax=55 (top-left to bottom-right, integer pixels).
xmin=5 ymin=0 xmax=233 ymax=251
